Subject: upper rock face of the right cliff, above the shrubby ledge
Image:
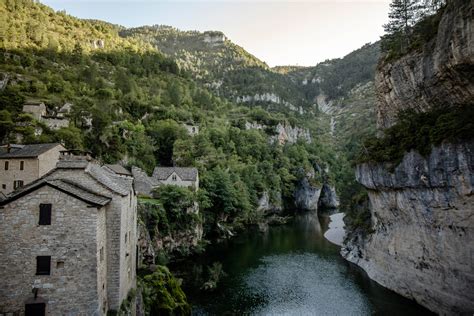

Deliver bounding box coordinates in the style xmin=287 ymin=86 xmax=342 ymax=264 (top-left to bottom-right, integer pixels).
xmin=375 ymin=0 xmax=474 ymax=128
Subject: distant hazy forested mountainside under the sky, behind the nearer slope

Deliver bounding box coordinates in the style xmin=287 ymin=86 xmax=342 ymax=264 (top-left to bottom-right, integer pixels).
xmin=120 ymin=25 xmax=314 ymax=115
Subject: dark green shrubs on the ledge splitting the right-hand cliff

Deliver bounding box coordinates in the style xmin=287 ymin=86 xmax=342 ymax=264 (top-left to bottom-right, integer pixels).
xmin=358 ymin=104 xmax=474 ymax=165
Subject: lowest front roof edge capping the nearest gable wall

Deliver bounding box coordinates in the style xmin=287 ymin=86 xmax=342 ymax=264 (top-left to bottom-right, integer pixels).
xmin=0 ymin=178 xmax=111 ymax=206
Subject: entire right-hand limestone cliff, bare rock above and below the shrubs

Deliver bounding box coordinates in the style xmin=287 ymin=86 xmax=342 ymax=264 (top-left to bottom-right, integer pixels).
xmin=342 ymin=0 xmax=474 ymax=315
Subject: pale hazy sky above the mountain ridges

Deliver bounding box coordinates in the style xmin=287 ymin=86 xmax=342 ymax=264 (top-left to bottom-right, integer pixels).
xmin=41 ymin=0 xmax=390 ymax=66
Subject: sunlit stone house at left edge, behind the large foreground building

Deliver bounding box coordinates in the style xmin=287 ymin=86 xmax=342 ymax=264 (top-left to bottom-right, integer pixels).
xmin=0 ymin=143 xmax=65 ymax=195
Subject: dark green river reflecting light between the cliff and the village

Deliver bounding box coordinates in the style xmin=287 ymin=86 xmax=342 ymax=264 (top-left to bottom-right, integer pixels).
xmin=175 ymin=214 xmax=430 ymax=315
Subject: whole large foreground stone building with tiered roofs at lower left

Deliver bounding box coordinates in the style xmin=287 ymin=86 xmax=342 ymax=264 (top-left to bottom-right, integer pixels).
xmin=0 ymin=152 xmax=137 ymax=316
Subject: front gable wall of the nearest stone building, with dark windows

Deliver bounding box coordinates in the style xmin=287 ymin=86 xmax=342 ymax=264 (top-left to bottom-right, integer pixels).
xmin=0 ymin=186 xmax=105 ymax=315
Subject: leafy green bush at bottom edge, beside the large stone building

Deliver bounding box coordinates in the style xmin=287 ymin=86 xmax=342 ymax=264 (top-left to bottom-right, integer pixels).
xmin=139 ymin=266 xmax=191 ymax=315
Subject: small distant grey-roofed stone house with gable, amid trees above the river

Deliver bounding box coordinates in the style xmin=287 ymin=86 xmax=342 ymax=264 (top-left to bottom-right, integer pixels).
xmin=132 ymin=167 xmax=199 ymax=196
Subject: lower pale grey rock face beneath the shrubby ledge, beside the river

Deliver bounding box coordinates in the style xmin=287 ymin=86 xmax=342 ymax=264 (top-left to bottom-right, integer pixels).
xmin=343 ymin=142 xmax=474 ymax=314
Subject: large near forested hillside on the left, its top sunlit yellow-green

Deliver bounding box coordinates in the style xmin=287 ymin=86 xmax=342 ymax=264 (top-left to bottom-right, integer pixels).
xmin=0 ymin=0 xmax=337 ymax=237
